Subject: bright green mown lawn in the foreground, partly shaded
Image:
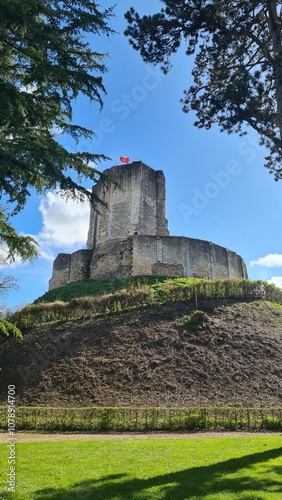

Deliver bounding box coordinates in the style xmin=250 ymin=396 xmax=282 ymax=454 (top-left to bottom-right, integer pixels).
xmin=0 ymin=434 xmax=282 ymax=500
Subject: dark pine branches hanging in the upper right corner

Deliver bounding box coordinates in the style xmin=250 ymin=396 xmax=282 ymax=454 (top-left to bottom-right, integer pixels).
xmin=125 ymin=0 xmax=282 ymax=180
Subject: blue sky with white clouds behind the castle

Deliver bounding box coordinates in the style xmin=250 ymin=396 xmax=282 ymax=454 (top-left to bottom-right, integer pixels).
xmin=0 ymin=0 xmax=282 ymax=307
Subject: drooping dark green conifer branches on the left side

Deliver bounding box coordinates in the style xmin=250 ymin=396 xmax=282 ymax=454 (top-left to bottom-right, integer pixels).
xmin=0 ymin=0 xmax=112 ymax=260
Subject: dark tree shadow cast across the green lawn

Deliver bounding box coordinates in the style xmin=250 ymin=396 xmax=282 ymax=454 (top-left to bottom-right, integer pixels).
xmin=33 ymin=447 xmax=282 ymax=500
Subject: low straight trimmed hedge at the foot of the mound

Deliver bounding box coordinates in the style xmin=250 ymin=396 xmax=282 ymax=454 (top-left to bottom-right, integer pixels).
xmin=0 ymin=407 xmax=282 ymax=432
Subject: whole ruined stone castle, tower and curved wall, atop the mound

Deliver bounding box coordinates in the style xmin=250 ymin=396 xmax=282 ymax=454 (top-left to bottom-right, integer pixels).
xmin=49 ymin=161 xmax=247 ymax=290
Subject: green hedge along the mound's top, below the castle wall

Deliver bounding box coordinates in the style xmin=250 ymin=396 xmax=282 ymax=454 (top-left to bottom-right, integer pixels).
xmin=8 ymin=278 xmax=282 ymax=331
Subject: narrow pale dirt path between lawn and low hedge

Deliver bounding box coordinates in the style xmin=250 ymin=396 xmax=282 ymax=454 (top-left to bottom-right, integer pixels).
xmin=0 ymin=432 xmax=282 ymax=444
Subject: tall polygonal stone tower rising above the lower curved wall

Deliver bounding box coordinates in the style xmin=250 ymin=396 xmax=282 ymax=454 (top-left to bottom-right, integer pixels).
xmin=87 ymin=162 xmax=169 ymax=249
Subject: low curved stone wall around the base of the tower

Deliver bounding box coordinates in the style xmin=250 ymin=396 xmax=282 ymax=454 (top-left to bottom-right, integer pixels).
xmin=49 ymin=235 xmax=248 ymax=290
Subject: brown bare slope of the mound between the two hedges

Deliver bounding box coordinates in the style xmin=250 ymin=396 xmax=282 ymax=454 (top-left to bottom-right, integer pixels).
xmin=0 ymin=301 xmax=282 ymax=406
